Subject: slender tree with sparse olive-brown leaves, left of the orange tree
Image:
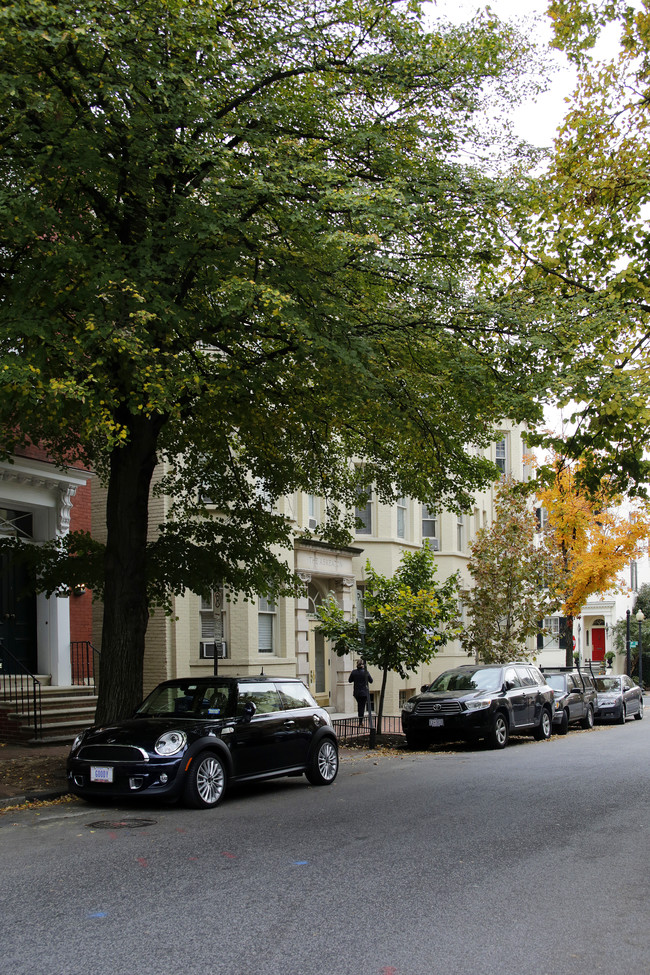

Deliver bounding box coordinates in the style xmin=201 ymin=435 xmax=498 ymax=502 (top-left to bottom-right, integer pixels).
xmin=461 ymin=479 xmax=558 ymax=663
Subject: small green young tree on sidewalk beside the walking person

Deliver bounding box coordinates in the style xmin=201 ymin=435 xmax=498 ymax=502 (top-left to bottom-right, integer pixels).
xmin=316 ymin=545 xmax=459 ymax=734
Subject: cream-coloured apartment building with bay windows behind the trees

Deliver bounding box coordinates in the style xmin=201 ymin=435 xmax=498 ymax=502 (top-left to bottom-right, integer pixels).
xmin=123 ymin=425 xmax=529 ymax=714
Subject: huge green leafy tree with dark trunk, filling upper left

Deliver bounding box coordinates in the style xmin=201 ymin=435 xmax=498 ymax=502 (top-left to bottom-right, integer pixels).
xmin=0 ymin=0 xmax=558 ymax=721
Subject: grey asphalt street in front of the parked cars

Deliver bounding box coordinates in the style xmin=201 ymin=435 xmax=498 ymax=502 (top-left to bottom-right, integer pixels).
xmin=0 ymin=720 xmax=650 ymax=975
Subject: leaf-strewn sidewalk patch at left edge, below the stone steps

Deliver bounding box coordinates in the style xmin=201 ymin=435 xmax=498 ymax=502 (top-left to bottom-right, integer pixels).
xmin=0 ymin=742 xmax=70 ymax=811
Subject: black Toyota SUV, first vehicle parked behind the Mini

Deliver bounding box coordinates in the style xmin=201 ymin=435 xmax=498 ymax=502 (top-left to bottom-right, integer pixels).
xmin=402 ymin=663 xmax=553 ymax=748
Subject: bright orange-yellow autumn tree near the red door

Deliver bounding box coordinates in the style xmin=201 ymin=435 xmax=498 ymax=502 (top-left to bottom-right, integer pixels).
xmin=537 ymin=455 xmax=650 ymax=666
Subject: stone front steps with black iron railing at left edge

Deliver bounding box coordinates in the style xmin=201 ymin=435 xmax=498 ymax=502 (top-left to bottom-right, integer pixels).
xmin=0 ymin=676 xmax=97 ymax=745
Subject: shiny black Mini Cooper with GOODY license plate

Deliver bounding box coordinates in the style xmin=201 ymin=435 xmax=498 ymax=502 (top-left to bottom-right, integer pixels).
xmin=67 ymin=676 xmax=339 ymax=808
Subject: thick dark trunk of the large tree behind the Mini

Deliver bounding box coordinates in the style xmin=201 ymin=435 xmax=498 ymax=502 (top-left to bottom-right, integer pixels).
xmin=96 ymin=417 xmax=161 ymax=724
